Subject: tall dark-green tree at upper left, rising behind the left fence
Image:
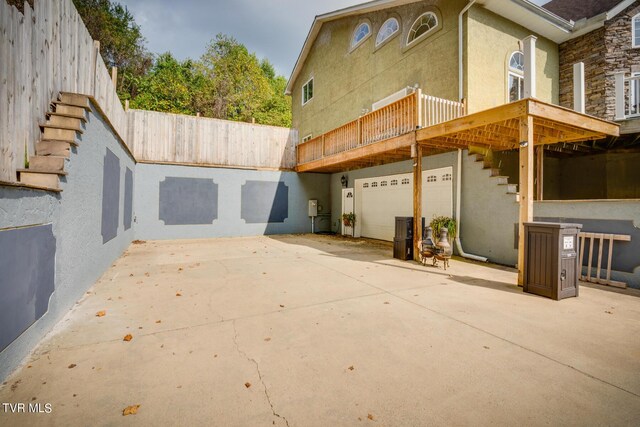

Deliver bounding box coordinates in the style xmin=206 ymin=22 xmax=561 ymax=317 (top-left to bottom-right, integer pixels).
xmin=73 ymin=0 xmax=153 ymax=100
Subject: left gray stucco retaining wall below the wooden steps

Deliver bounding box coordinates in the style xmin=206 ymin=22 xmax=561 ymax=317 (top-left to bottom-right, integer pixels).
xmin=0 ymin=103 xmax=135 ymax=378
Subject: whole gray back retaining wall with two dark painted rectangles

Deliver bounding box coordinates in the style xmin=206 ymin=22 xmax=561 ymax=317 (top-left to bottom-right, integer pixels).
xmin=134 ymin=163 xmax=331 ymax=239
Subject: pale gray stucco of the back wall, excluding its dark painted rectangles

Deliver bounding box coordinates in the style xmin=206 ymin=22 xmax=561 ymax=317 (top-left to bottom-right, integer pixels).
xmin=134 ymin=163 xmax=331 ymax=240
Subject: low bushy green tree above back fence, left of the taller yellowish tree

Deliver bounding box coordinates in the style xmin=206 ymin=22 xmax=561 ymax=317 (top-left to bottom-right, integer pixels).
xmin=130 ymin=52 xmax=204 ymax=115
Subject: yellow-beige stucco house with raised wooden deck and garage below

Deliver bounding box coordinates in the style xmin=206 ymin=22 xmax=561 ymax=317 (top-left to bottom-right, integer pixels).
xmin=287 ymin=0 xmax=640 ymax=284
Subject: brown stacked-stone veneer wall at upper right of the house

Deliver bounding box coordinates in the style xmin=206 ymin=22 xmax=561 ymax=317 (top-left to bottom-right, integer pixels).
xmin=560 ymin=1 xmax=640 ymax=120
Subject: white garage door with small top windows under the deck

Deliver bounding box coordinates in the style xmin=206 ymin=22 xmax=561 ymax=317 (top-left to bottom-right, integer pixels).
xmin=354 ymin=167 xmax=453 ymax=241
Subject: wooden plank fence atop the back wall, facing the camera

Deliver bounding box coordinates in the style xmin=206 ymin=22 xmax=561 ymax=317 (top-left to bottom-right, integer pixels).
xmin=127 ymin=110 xmax=298 ymax=169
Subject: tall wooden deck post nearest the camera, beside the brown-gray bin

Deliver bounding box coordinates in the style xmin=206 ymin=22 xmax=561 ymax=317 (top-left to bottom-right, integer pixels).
xmin=518 ymin=114 xmax=534 ymax=286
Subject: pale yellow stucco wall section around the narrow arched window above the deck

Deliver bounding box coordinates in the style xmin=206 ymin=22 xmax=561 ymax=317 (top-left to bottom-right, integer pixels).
xmin=465 ymin=6 xmax=559 ymax=112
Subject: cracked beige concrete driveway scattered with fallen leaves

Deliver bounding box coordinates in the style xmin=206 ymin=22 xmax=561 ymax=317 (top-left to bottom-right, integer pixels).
xmin=0 ymin=235 xmax=640 ymax=426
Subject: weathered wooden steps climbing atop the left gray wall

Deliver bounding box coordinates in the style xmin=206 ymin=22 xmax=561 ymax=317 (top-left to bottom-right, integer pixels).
xmin=18 ymin=92 xmax=91 ymax=192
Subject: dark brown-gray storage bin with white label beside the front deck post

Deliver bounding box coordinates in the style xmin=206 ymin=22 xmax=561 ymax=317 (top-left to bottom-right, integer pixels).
xmin=523 ymin=222 xmax=582 ymax=300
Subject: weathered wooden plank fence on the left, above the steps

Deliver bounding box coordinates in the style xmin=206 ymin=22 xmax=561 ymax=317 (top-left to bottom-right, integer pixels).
xmin=0 ymin=0 xmax=127 ymax=182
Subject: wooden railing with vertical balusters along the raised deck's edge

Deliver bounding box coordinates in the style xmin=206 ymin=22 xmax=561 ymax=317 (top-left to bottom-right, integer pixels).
xmin=297 ymin=90 xmax=465 ymax=164
